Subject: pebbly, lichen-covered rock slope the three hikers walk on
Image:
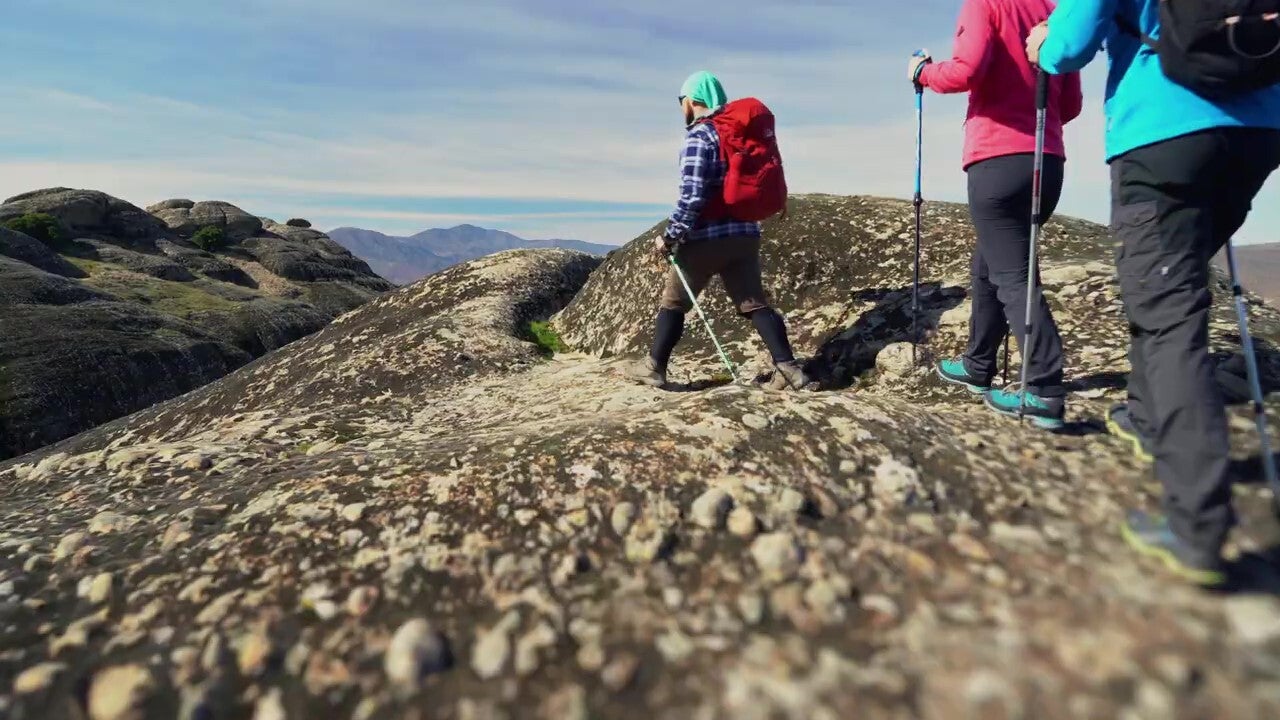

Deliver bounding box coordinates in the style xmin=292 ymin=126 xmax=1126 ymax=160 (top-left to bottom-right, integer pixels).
xmin=0 ymin=196 xmax=1280 ymax=720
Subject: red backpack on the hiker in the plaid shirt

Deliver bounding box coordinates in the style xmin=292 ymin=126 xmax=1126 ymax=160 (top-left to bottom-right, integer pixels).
xmin=704 ymin=97 xmax=787 ymax=223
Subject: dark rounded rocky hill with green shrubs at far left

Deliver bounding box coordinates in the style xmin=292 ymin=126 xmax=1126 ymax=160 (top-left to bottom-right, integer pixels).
xmin=0 ymin=188 xmax=392 ymax=459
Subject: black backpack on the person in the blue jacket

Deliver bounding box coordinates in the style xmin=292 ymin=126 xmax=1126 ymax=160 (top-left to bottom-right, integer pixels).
xmin=1116 ymin=0 xmax=1280 ymax=100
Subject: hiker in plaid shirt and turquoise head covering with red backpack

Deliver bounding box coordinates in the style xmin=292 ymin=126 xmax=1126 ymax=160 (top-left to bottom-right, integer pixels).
xmin=626 ymin=72 xmax=809 ymax=389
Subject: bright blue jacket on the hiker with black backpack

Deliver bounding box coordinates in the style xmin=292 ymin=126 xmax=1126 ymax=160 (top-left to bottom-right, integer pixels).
xmin=1039 ymin=0 xmax=1280 ymax=163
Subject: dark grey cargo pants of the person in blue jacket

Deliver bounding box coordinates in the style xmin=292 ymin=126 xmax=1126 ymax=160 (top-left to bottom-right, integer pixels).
xmin=1111 ymin=128 xmax=1280 ymax=566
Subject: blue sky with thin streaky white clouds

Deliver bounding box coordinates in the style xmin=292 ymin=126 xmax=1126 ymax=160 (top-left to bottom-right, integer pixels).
xmin=0 ymin=0 xmax=1280 ymax=242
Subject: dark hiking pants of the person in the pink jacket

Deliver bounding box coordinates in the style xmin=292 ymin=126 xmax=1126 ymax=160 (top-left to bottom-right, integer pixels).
xmin=964 ymin=154 xmax=1066 ymax=397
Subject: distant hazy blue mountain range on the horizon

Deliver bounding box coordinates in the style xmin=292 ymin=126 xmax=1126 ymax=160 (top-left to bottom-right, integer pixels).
xmin=329 ymin=225 xmax=617 ymax=284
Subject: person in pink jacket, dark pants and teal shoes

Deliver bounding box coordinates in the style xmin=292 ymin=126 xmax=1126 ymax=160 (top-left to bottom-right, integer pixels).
xmin=909 ymin=0 xmax=1083 ymax=429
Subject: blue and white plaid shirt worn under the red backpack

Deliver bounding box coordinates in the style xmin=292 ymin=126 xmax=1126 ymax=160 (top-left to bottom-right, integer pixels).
xmin=664 ymin=116 xmax=760 ymax=242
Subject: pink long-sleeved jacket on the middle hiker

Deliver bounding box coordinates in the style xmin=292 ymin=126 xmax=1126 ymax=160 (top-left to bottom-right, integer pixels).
xmin=920 ymin=0 xmax=1084 ymax=169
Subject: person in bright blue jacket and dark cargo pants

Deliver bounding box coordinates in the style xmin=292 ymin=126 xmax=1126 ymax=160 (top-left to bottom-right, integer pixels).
xmin=1027 ymin=0 xmax=1280 ymax=585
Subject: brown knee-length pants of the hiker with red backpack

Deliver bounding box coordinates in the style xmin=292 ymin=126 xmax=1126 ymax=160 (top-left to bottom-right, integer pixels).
xmin=660 ymin=236 xmax=769 ymax=315
